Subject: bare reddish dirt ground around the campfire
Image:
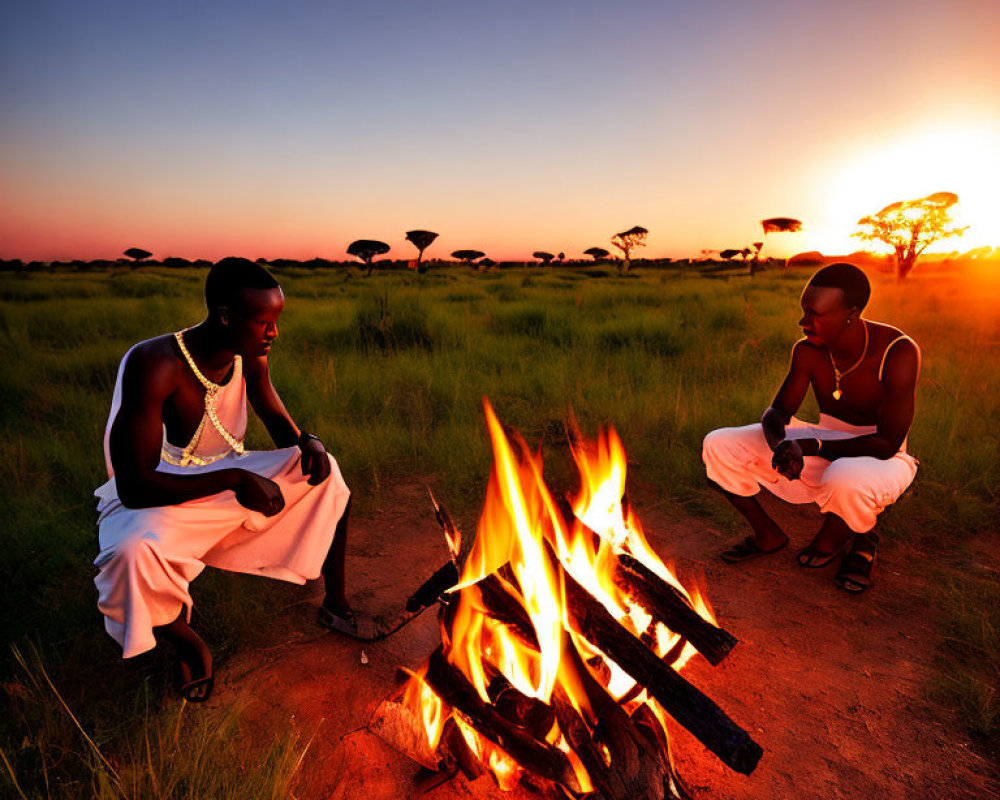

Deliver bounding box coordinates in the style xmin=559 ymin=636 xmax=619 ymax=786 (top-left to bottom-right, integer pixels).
xmin=212 ymin=484 xmax=997 ymax=800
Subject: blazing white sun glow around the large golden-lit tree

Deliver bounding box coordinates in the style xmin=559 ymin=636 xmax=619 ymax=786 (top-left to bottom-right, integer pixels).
xmin=809 ymin=121 xmax=1000 ymax=253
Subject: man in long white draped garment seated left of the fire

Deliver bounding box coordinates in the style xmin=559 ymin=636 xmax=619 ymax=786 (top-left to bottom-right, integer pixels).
xmin=94 ymin=258 xmax=356 ymax=702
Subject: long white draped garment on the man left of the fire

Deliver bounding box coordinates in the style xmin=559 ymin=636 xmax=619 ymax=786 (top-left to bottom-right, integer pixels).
xmin=94 ymin=338 xmax=350 ymax=658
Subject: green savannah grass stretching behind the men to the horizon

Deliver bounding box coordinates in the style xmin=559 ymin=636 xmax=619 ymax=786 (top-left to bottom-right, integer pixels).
xmin=0 ymin=267 xmax=1000 ymax=798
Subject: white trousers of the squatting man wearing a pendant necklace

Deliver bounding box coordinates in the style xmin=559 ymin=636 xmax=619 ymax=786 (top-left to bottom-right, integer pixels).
xmin=702 ymin=414 xmax=917 ymax=533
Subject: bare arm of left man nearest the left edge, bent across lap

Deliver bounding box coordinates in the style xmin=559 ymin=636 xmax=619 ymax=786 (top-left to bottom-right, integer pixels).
xmin=110 ymin=350 xmax=284 ymax=515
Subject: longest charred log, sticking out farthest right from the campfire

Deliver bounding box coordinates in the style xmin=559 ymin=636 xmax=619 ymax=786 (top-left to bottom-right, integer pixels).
xmin=564 ymin=571 xmax=764 ymax=775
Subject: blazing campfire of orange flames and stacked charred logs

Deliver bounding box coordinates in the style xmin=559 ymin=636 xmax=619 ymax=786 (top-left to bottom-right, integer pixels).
xmin=370 ymin=401 xmax=762 ymax=800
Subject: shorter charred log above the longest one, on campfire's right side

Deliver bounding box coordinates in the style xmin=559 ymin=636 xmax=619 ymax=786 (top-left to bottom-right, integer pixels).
xmin=614 ymin=553 xmax=737 ymax=667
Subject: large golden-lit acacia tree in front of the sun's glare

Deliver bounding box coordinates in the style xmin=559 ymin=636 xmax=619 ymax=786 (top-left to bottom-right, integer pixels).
xmin=852 ymin=192 xmax=969 ymax=281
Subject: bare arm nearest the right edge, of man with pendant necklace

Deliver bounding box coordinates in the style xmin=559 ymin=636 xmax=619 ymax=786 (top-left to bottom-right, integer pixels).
xmin=818 ymin=341 xmax=920 ymax=461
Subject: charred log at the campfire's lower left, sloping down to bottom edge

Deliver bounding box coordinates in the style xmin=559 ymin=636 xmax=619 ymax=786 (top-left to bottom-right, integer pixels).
xmin=424 ymin=648 xmax=582 ymax=794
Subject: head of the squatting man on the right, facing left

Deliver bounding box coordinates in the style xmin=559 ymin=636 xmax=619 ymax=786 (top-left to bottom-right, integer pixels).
xmin=799 ymin=262 xmax=872 ymax=345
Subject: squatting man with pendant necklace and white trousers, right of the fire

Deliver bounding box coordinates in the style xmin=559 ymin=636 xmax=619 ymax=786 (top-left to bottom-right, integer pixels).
xmin=702 ymin=264 xmax=920 ymax=592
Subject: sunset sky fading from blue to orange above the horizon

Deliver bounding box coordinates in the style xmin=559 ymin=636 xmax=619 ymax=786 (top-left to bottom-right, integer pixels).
xmin=0 ymin=0 xmax=1000 ymax=260
